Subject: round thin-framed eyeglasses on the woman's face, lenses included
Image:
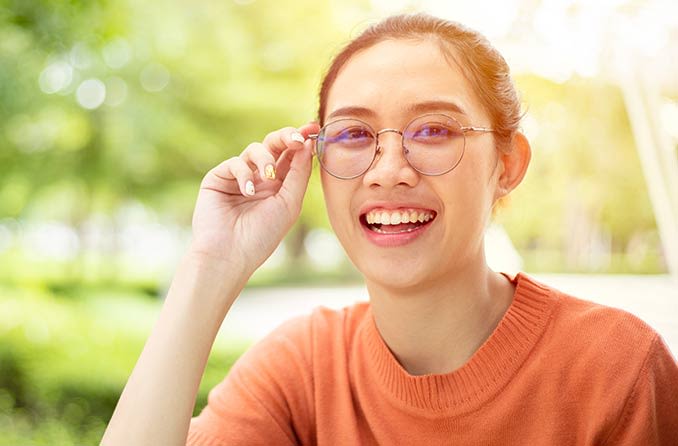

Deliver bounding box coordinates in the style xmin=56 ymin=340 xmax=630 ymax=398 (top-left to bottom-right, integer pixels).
xmin=309 ymin=113 xmax=494 ymax=180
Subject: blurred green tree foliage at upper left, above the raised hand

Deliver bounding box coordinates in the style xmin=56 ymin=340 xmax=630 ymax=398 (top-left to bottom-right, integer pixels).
xmin=0 ymin=0 xmax=348 ymax=225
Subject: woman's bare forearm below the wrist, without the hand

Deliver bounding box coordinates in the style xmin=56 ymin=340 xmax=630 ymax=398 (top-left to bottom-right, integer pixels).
xmin=101 ymin=254 xmax=247 ymax=446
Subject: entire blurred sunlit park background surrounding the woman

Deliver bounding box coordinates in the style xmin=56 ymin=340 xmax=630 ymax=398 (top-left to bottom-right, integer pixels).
xmin=0 ymin=0 xmax=678 ymax=445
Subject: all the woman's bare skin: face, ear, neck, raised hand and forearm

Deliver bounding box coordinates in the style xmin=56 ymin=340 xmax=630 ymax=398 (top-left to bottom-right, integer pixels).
xmin=101 ymin=35 xmax=530 ymax=446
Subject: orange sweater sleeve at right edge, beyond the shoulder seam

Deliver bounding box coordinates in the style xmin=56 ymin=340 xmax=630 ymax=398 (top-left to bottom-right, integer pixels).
xmin=605 ymin=335 xmax=678 ymax=446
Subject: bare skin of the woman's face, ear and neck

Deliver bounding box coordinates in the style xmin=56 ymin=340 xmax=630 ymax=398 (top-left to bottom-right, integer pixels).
xmin=322 ymin=40 xmax=530 ymax=375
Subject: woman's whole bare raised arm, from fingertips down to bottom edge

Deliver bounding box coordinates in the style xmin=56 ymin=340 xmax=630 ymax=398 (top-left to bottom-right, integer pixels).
xmin=101 ymin=124 xmax=318 ymax=446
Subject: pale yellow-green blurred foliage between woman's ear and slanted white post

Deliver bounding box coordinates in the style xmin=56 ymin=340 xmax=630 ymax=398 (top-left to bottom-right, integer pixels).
xmin=498 ymin=76 xmax=665 ymax=273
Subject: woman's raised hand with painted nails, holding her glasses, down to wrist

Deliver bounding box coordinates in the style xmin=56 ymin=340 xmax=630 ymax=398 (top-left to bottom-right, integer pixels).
xmin=190 ymin=123 xmax=319 ymax=274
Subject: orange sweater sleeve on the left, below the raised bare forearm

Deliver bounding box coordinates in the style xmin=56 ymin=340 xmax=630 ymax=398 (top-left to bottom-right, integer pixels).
xmin=187 ymin=317 xmax=313 ymax=446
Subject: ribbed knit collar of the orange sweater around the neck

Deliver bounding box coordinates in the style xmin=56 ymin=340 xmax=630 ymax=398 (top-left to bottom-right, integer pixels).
xmin=360 ymin=273 xmax=556 ymax=415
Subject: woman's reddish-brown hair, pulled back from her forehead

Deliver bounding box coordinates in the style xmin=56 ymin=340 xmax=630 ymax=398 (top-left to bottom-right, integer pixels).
xmin=318 ymin=13 xmax=522 ymax=150
